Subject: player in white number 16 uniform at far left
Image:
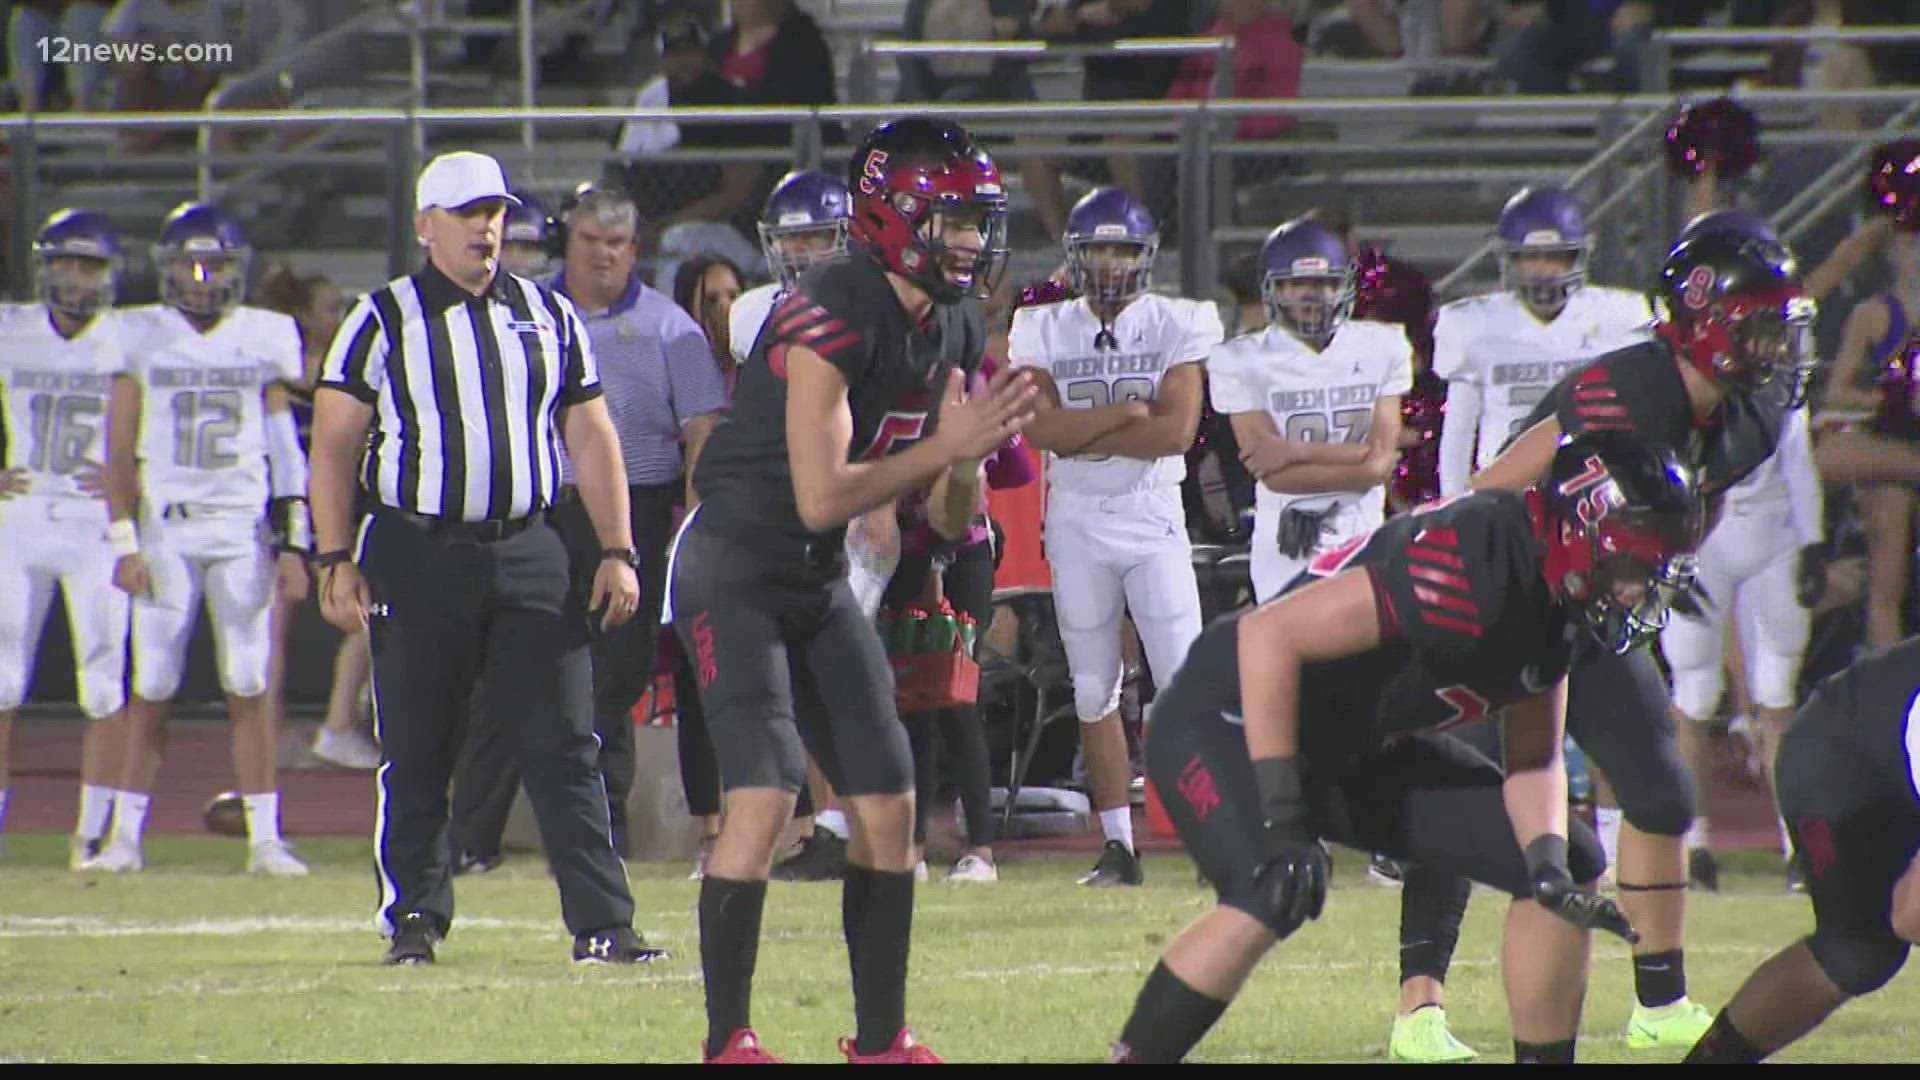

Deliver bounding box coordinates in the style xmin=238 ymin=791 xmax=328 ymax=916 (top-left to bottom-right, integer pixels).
xmin=0 ymin=209 xmax=127 ymax=869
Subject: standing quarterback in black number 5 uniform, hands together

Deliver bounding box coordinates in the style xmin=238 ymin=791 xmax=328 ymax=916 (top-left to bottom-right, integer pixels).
xmin=666 ymin=117 xmax=1033 ymax=1063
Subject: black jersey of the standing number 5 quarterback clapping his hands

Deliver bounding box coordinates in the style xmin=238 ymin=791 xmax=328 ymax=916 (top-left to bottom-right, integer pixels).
xmin=695 ymin=254 xmax=987 ymax=550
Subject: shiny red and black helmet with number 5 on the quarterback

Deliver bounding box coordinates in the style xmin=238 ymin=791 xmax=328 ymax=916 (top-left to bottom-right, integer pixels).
xmin=847 ymin=117 xmax=1008 ymax=304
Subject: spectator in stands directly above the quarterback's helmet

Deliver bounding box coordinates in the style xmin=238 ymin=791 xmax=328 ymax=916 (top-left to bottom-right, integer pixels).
xmin=897 ymin=0 xmax=1068 ymax=236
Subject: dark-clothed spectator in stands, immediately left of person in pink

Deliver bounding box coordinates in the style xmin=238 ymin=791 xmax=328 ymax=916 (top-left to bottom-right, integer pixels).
xmin=1039 ymin=0 xmax=1188 ymax=212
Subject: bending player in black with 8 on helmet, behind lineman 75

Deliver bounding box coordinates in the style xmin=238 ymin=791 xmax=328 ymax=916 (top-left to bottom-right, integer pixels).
xmin=1404 ymin=233 xmax=1812 ymax=1049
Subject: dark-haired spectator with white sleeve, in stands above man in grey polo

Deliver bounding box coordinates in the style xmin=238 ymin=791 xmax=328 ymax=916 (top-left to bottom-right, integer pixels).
xmin=616 ymin=19 xmax=766 ymax=288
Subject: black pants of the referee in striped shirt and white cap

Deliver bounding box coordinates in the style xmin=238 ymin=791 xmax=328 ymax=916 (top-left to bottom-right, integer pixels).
xmin=359 ymin=509 xmax=634 ymax=934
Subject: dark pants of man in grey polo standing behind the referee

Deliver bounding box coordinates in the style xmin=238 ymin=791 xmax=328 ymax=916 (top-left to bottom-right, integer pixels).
xmin=453 ymin=482 xmax=684 ymax=857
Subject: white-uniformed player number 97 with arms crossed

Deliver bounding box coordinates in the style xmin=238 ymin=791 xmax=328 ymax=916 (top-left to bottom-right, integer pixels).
xmin=1208 ymin=219 xmax=1413 ymax=603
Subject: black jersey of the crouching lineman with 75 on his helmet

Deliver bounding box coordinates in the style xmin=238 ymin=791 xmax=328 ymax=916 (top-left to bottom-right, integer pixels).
xmin=1181 ymin=492 xmax=1572 ymax=767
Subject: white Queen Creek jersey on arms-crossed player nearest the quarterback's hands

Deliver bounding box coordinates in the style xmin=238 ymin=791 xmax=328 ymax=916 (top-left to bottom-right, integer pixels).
xmin=1006 ymin=292 xmax=1225 ymax=496
